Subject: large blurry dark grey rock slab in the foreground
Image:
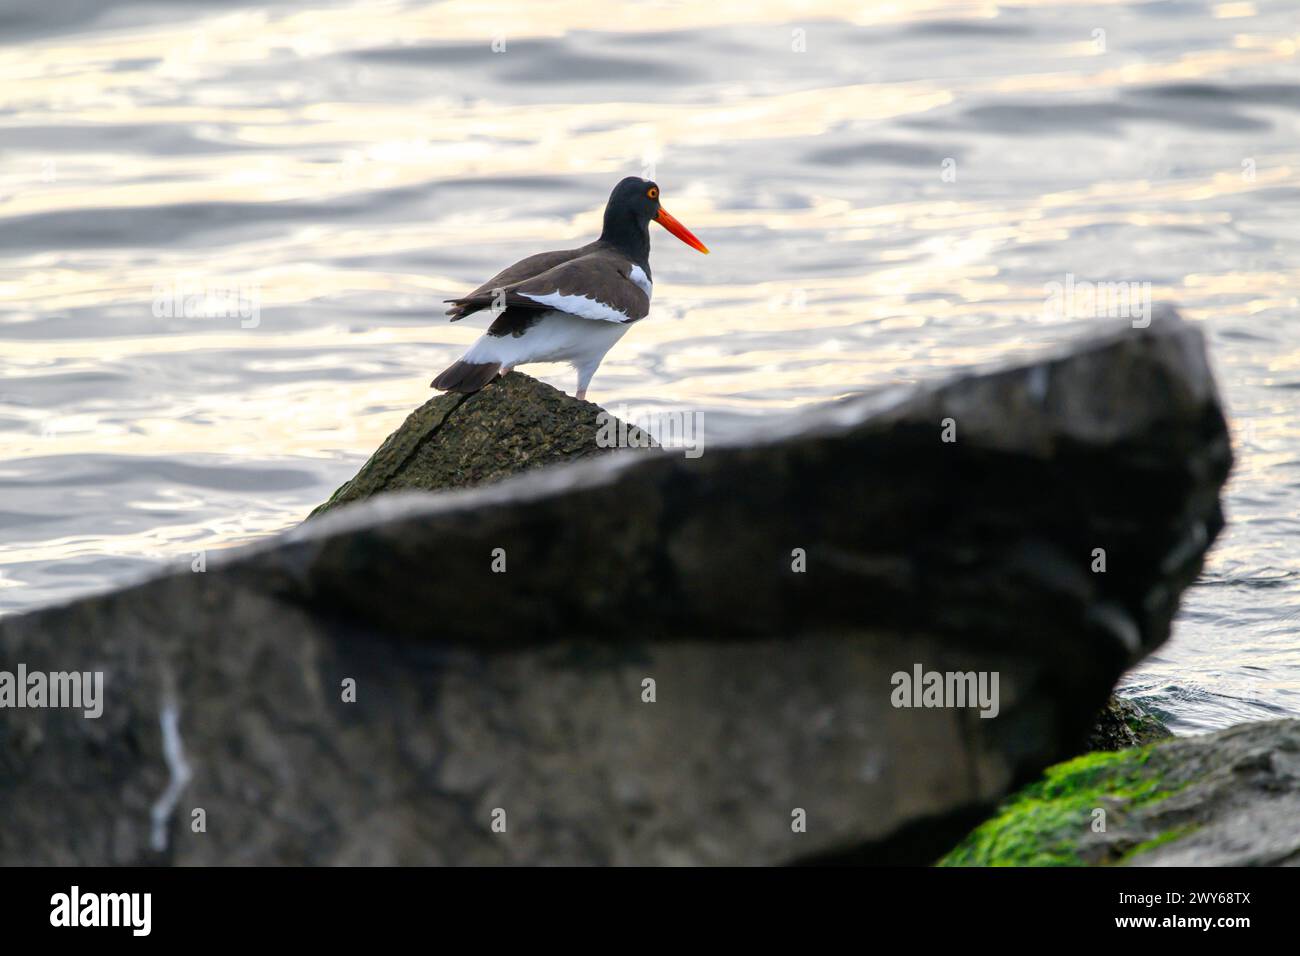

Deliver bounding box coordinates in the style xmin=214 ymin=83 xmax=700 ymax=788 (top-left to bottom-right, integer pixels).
xmin=0 ymin=316 xmax=1230 ymax=864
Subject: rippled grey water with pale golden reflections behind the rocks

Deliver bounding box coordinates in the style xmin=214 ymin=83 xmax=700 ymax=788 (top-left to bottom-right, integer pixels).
xmin=0 ymin=0 xmax=1300 ymax=731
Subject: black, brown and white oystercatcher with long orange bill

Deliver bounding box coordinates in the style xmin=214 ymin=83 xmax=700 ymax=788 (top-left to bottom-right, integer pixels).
xmin=433 ymin=176 xmax=709 ymax=398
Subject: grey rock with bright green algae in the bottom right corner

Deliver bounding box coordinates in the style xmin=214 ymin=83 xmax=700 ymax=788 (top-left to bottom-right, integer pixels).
xmin=939 ymin=721 xmax=1300 ymax=866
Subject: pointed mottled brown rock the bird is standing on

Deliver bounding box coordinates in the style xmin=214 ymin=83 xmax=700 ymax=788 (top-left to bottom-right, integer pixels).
xmin=308 ymin=372 xmax=655 ymax=518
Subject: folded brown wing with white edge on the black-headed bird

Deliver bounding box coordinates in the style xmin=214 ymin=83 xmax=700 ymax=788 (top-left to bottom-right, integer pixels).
xmin=454 ymin=250 xmax=650 ymax=323
